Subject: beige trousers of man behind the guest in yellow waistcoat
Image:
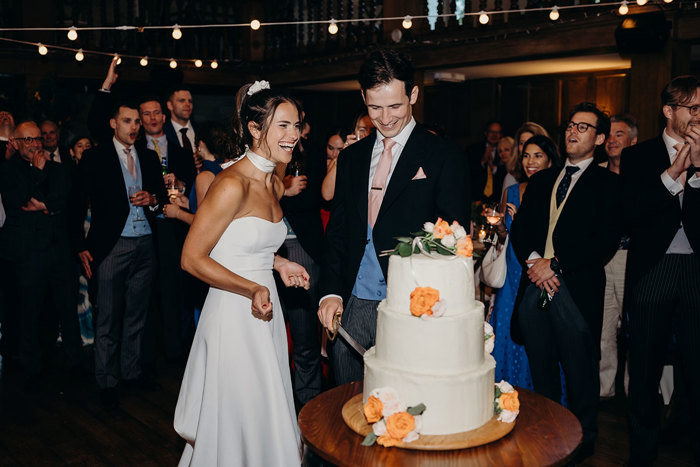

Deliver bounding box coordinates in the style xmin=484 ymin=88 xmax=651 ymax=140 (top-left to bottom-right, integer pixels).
xmin=600 ymin=250 xmax=627 ymax=397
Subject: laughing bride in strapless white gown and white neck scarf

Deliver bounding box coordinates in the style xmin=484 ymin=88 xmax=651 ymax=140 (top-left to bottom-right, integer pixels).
xmin=175 ymin=81 xmax=309 ymax=466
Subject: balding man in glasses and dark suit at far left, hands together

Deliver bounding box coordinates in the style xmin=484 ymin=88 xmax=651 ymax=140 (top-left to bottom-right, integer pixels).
xmin=0 ymin=122 xmax=81 ymax=390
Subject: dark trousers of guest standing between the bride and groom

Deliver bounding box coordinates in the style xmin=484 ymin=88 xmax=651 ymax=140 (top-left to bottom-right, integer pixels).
xmin=279 ymin=239 xmax=321 ymax=404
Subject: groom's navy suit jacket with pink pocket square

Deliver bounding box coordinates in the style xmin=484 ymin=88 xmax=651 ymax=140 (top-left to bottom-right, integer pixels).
xmin=320 ymin=125 xmax=470 ymax=303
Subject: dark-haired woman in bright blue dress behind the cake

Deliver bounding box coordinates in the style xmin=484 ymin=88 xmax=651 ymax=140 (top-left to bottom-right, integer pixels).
xmin=490 ymin=135 xmax=565 ymax=394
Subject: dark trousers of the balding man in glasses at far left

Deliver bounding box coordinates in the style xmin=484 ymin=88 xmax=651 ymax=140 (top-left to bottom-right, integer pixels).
xmin=15 ymin=243 xmax=82 ymax=375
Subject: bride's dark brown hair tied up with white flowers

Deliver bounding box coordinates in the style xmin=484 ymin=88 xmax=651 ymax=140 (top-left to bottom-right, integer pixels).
xmin=233 ymin=81 xmax=303 ymax=156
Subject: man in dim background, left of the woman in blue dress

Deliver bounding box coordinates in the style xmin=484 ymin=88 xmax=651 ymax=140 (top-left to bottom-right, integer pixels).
xmin=467 ymin=121 xmax=507 ymax=202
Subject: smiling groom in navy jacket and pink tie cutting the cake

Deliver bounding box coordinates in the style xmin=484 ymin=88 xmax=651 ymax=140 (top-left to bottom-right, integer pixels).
xmin=318 ymin=50 xmax=469 ymax=384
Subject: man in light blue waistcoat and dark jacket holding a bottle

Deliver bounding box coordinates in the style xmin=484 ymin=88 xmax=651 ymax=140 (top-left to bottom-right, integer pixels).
xmin=74 ymin=103 xmax=167 ymax=406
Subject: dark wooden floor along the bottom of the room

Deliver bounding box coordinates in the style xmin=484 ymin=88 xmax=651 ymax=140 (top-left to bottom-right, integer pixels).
xmin=0 ymin=350 xmax=693 ymax=467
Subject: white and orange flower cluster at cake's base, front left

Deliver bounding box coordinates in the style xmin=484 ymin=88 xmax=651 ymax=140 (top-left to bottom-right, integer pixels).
xmin=362 ymin=387 xmax=425 ymax=447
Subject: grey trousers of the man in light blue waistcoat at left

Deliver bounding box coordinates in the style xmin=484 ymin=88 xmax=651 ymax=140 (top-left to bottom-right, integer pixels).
xmin=94 ymin=235 xmax=156 ymax=388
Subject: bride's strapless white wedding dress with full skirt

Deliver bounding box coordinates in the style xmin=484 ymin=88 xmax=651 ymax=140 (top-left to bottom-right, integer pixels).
xmin=175 ymin=217 xmax=301 ymax=466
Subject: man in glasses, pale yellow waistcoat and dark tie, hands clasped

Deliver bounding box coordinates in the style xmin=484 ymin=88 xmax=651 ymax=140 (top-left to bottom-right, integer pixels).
xmin=511 ymin=102 xmax=621 ymax=460
